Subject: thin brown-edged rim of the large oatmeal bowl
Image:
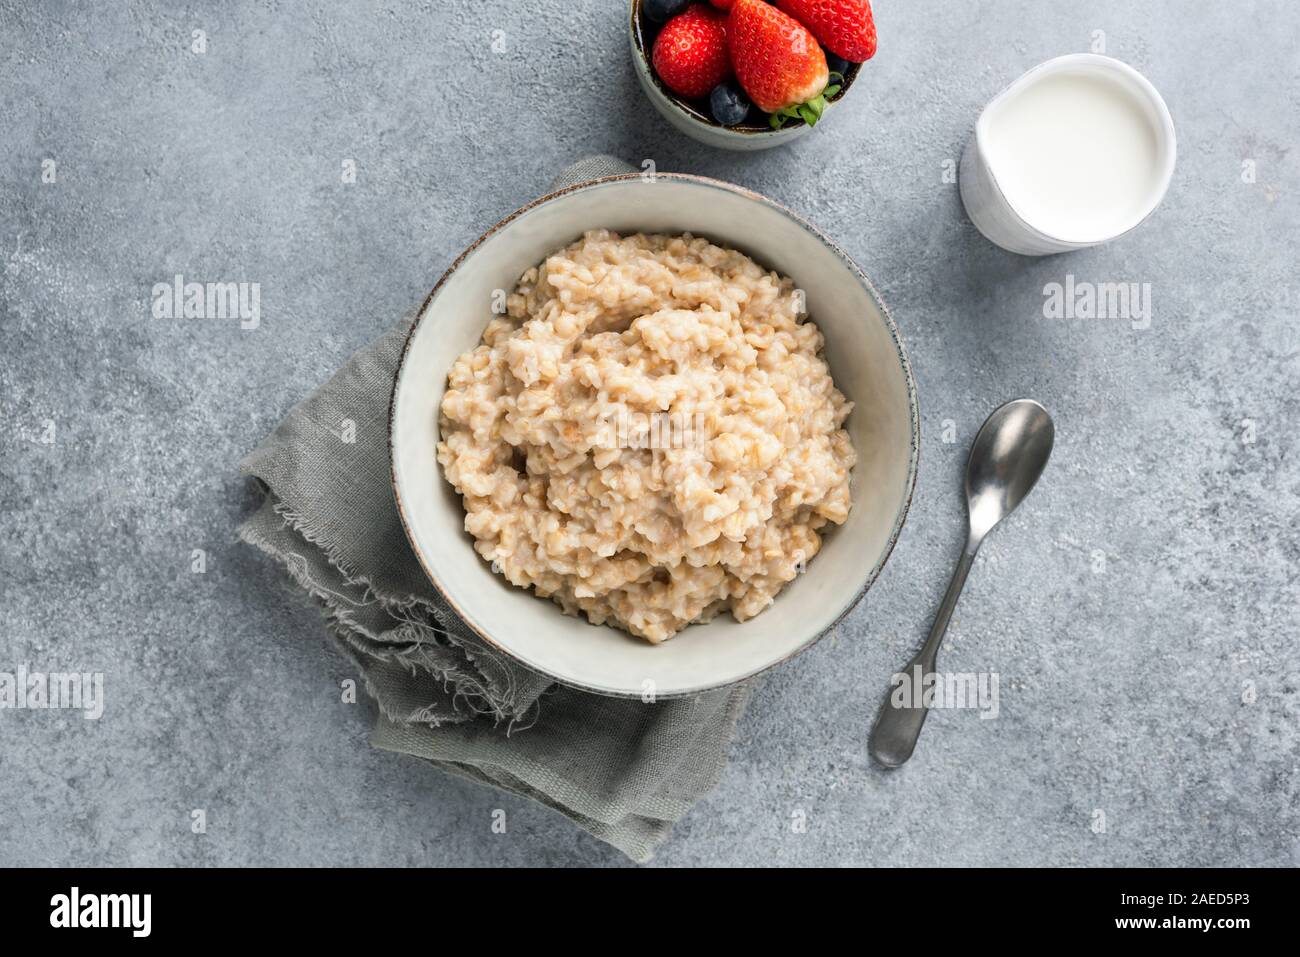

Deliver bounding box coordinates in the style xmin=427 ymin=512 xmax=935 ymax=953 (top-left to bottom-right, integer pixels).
xmin=389 ymin=172 xmax=920 ymax=700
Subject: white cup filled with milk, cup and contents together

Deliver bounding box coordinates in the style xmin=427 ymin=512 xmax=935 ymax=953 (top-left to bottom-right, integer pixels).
xmin=961 ymin=53 xmax=1178 ymax=256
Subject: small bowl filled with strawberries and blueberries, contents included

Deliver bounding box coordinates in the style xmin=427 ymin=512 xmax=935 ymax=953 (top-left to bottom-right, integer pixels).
xmin=631 ymin=0 xmax=876 ymax=150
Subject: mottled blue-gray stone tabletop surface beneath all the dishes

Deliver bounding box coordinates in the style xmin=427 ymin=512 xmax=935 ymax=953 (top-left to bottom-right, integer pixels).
xmin=0 ymin=0 xmax=1300 ymax=865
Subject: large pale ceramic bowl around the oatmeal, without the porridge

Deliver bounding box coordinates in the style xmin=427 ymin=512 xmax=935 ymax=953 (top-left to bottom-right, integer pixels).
xmin=390 ymin=173 xmax=919 ymax=697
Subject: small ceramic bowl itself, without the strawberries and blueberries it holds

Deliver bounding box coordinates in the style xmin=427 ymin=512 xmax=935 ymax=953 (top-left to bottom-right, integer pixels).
xmin=628 ymin=0 xmax=862 ymax=151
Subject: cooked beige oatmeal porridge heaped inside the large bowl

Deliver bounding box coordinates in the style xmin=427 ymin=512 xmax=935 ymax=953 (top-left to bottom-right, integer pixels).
xmin=438 ymin=230 xmax=855 ymax=642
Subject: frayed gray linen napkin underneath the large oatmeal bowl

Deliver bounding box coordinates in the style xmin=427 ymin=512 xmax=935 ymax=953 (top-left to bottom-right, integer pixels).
xmin=239 ymin=156 xmax=751 ymax=861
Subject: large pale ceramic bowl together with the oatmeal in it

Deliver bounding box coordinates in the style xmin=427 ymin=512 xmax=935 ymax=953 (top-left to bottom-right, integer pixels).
xmin=391 ymin=173 xmax=918 ymax=696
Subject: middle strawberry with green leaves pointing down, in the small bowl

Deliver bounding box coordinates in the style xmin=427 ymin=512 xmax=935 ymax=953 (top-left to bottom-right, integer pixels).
xmin=727 ymin=0 xmax=837 ymax=127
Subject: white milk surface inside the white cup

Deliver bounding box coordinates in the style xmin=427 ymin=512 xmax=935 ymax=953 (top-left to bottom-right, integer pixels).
xmin=985 ymin=72 xmax=1160 ymax=242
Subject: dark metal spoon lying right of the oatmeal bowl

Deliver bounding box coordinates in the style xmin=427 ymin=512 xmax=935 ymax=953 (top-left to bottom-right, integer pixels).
xmin=871 ymin=399 xmax=1056 ymax=767
